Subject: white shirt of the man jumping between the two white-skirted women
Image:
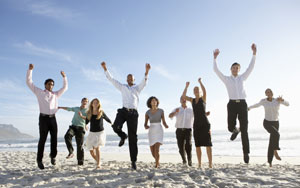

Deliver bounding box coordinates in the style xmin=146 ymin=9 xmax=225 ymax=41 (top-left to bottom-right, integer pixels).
xmin=105 ymin=70 xmax=147 ymax=110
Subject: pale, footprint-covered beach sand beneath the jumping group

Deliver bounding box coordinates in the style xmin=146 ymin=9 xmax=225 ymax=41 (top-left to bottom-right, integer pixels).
xmin=0 ymin=151 xmax=300 ymax=188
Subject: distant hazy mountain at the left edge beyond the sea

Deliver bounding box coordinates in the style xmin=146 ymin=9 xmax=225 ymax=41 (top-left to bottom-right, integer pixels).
xmin=0 ymin=124 xmax=33 ymax=140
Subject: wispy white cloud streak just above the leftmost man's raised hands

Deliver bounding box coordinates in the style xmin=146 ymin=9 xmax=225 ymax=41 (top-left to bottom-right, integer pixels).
xmin=14 ymin=41 xmax=72 ymax=62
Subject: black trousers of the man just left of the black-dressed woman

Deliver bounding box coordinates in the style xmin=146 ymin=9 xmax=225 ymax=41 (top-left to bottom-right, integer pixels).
xmin=176 ymin=128 xmax=192 ymax=162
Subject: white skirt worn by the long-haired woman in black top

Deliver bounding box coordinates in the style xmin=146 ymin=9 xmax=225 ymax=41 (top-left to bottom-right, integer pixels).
xmin=85 ymin=130 xmax=106 ymax=150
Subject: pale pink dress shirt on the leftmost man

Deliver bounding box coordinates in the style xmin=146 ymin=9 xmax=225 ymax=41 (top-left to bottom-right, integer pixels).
xmin=26 ymin=70 xmax=68 ymax=115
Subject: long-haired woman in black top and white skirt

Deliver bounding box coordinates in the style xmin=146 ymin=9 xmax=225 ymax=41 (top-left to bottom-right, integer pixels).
xmin=79 ymin=98 xmax=111 ymax=168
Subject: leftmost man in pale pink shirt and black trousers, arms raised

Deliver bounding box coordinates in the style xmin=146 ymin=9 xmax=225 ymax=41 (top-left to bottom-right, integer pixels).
xmin=26 ymin=64 xmax=68 ymax=169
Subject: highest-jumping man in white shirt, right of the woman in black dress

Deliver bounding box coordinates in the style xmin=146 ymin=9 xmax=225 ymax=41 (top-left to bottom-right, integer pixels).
xmin=214 ymin=44 xmax=257 ymax=163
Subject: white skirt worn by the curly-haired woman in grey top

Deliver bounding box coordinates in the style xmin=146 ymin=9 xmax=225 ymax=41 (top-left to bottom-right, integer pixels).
xmin=148 ymin=123 xmax=164 ymax=146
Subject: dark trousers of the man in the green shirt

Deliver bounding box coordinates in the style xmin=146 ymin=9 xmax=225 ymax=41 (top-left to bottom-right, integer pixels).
xmin=65 ymin=125 xmax=85 ymax=161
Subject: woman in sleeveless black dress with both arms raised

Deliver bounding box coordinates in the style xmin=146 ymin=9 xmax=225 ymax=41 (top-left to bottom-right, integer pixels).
xmin=182 ymin=78 xmax=212 ymax=168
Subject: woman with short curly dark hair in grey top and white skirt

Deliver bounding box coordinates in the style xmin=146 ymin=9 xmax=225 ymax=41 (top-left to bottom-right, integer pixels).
xmin=144 ymin=96 xmax=169 ymax=168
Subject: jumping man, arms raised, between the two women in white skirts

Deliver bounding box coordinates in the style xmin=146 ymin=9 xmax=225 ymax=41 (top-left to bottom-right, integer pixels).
xmin=101 ymin=62 xmax=151 ymax=170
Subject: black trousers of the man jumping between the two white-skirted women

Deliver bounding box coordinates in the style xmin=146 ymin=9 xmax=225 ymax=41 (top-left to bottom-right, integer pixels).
xmin=113 ymin=108 xmax=139 ymax=162
